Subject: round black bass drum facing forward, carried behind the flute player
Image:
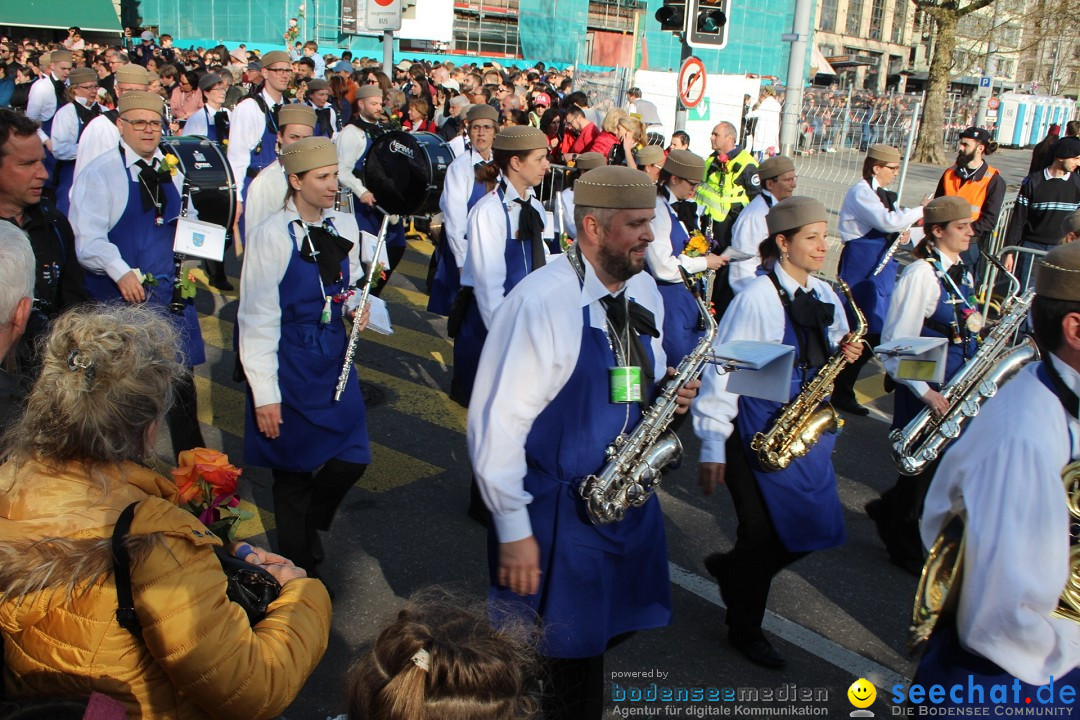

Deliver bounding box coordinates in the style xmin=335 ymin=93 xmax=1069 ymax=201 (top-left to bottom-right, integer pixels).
xmin=361 ymin=131 xmax=454 ymax=215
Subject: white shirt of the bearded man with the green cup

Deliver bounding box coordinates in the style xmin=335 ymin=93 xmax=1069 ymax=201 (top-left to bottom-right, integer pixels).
xmin=468 ymin=250 xmax=666 ymax=543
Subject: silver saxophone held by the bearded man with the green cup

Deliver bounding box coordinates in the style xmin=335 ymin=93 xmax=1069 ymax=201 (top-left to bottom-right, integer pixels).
xmin=567 ymin=263 xmax=716 ymax=525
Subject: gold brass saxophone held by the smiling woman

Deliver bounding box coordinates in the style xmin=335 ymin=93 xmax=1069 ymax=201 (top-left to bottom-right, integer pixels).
xmin=750 ymin=280 xmax=866 ymax=472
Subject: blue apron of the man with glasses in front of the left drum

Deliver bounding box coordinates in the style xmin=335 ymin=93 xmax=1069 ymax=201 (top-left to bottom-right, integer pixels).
xmin=83 ymin=149 xmax=206 ymax=367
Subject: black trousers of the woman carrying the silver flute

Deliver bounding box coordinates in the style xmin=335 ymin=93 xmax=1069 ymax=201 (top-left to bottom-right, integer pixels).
xmin=273 ymin=459 xmax=367 ymax=576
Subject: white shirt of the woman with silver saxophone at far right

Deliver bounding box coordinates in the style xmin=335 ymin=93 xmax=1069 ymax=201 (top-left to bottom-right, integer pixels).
xmin=881 ymin=253 xmax=954 ymax=398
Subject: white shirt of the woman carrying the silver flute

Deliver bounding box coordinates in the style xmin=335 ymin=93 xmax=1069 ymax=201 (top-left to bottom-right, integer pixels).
xmin=237 ymin=203 xmax=364 ymax=407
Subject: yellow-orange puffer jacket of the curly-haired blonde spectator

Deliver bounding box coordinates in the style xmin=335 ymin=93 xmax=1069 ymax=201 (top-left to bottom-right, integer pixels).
xmin=0 ymin=462 xmax=330 ymax=719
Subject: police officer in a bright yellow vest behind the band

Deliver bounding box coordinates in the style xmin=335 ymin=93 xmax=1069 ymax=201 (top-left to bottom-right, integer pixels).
xmin=696 ymin=122 xmax=761 ymax=316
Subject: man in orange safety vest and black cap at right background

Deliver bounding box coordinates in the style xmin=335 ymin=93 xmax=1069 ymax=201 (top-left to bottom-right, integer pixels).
xmin=934 ymin=127 xmax=1005 ymax=276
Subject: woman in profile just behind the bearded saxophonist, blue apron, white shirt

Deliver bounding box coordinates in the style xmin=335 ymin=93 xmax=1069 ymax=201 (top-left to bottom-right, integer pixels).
xmin=645 ymin=150 xmax=727 ymax=365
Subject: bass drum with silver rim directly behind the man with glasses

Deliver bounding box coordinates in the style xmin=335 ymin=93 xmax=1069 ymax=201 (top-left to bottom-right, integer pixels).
xmin=161 ymin=135 xmax=237 ymax=234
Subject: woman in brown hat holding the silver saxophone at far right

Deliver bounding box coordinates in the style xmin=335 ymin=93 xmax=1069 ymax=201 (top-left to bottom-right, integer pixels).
xmin=866 ymin=195 xmax=982 ymax=575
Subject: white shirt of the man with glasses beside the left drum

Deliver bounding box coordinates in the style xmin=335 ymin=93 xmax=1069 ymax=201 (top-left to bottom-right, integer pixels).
xmin=68 ymin=140 xmax=187 ymax=282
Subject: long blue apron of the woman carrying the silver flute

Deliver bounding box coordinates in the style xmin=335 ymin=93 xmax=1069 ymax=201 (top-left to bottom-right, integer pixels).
xmin=244 ymin=223 xmax=372 ymax=473
